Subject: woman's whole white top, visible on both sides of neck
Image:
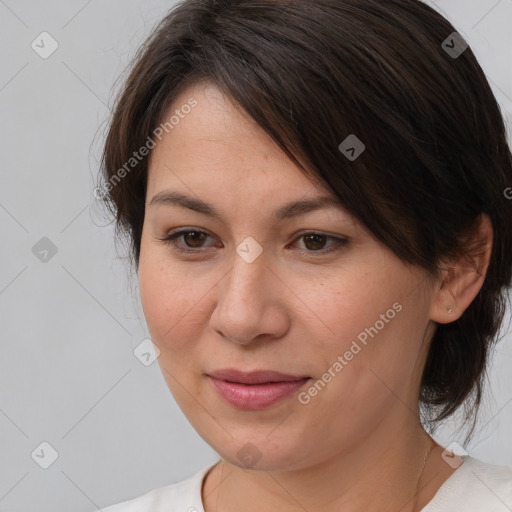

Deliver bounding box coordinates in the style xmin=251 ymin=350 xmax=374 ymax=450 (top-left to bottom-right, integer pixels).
xmin=103 ymin=455 xmax=512 ymax=512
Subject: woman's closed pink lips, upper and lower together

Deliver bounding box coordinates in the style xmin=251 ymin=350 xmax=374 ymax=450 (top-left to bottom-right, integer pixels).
xmin=208 ymin=370 xmax=310 ymax=410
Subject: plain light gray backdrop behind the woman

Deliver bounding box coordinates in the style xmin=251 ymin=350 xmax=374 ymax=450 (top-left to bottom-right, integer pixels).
xmin=0 ymin=0 xmax=512 ymax=512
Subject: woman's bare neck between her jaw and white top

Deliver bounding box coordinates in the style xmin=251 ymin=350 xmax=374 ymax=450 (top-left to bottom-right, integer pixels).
xmin=203 ymin=416 xmax=446 ymax=512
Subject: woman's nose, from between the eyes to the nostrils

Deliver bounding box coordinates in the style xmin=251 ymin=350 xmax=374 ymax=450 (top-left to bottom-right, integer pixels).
xmin=210 ymin=253 xmax=290 ymax=345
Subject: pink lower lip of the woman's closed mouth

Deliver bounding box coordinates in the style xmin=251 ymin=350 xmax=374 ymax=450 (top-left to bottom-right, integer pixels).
xmin=210 ymin=377 xmax=309 ymax=410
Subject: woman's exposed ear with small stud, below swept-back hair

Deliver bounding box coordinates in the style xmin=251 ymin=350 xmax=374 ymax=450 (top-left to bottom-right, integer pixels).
xmin=430 ymin=213 xmax=493 ymax=324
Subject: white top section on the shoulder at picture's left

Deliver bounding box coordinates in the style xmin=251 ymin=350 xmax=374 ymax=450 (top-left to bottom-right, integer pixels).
xmin=101 ymin=463 xmax=217 ymax=512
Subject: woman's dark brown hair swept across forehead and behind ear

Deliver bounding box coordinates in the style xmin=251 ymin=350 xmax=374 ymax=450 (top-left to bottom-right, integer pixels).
xmin=101 ymin=0 xmax=512 ymax=440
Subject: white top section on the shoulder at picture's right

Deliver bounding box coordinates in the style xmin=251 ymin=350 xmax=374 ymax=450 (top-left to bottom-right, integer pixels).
xmin=422 ymin=455 xmax=512 ymax=512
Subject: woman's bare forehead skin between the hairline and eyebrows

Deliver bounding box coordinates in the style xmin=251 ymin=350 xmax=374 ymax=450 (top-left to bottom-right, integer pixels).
xmin=148 ymin=84 xmax=331 ymax=194
